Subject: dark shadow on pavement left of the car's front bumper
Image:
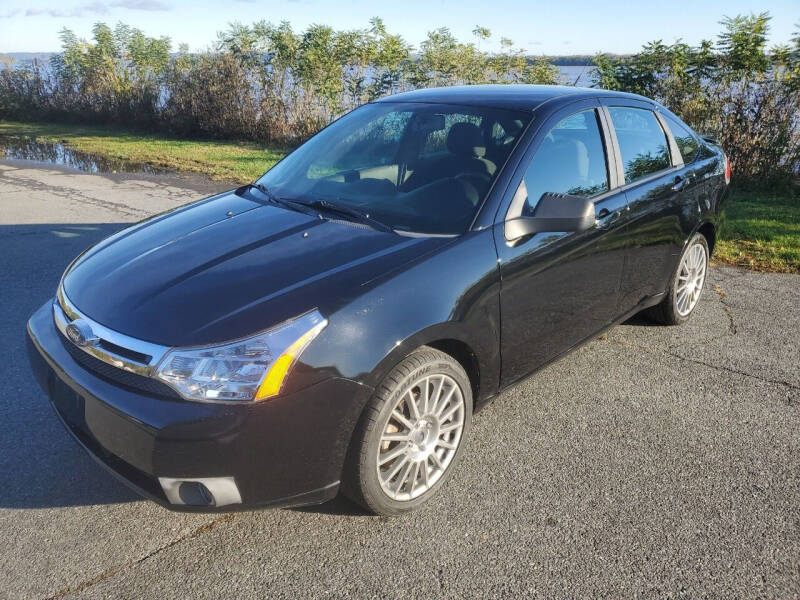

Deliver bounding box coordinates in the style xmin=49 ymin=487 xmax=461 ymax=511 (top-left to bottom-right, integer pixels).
xmin=0 ymin=223 xmax=139 ymax=508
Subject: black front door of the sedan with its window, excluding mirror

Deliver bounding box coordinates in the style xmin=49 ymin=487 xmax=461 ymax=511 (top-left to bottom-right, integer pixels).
xmin=495 ymin=102 xmax=627 ymax=385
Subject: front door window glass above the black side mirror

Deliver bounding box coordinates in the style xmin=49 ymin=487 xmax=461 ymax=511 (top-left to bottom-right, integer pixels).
xmin=517 ymin=110 xmax=608 ymax=215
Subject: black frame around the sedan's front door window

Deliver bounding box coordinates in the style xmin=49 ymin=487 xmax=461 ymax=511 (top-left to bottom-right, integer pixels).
xmin=503 ymin=103 xmax=619 ymax=229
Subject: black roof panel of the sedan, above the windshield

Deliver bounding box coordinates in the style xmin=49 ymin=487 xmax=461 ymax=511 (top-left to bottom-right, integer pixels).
xmin=378 ymin=84 xmax=652 ymax=110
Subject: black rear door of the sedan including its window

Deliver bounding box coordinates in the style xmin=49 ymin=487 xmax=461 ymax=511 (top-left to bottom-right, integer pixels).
xmin=603 ymin=100 xmax=699 ymax=312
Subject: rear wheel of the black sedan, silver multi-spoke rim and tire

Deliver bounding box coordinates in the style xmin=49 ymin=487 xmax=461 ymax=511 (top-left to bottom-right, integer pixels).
xmin=645 ymin=233 xmax=709 ymax=325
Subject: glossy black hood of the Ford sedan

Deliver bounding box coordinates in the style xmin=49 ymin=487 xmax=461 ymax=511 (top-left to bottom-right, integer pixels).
xmin=63 ymin=190 xmax=447 ymax=346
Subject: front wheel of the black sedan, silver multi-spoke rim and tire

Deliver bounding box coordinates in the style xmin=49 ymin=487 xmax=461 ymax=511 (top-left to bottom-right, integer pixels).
xmin=342 ymin=346 xmax=473 ymax=516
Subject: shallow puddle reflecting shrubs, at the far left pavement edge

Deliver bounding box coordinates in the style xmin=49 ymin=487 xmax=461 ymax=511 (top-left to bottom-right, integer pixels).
xmin=0 ymin=136 xmax=169 ymax=175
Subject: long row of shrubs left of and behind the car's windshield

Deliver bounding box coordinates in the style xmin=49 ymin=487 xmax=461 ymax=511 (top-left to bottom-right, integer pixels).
xmin=0 ymin=18 xmax=557 ymax=143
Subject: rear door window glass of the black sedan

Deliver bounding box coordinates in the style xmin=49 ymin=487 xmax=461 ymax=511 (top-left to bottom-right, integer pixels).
xmin=608 ymin=106 xmax=671 ymax=183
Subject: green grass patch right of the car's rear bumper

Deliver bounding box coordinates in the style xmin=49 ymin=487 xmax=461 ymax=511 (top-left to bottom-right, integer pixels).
xmin=714 ymin=190 xmax=800 ymax=273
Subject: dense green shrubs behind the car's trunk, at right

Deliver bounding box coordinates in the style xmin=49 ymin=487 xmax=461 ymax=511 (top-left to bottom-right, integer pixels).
xmin=595 ymin=13 xmax=800 ymax=185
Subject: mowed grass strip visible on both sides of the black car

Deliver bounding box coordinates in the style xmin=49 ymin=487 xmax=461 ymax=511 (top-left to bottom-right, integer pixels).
xmin=0 ymin=121 xmax=800 ymax=273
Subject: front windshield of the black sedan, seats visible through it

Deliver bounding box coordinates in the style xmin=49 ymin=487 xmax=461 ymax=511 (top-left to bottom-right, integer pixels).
xmin=257 ymin=102 xmax=530 ymax=234
